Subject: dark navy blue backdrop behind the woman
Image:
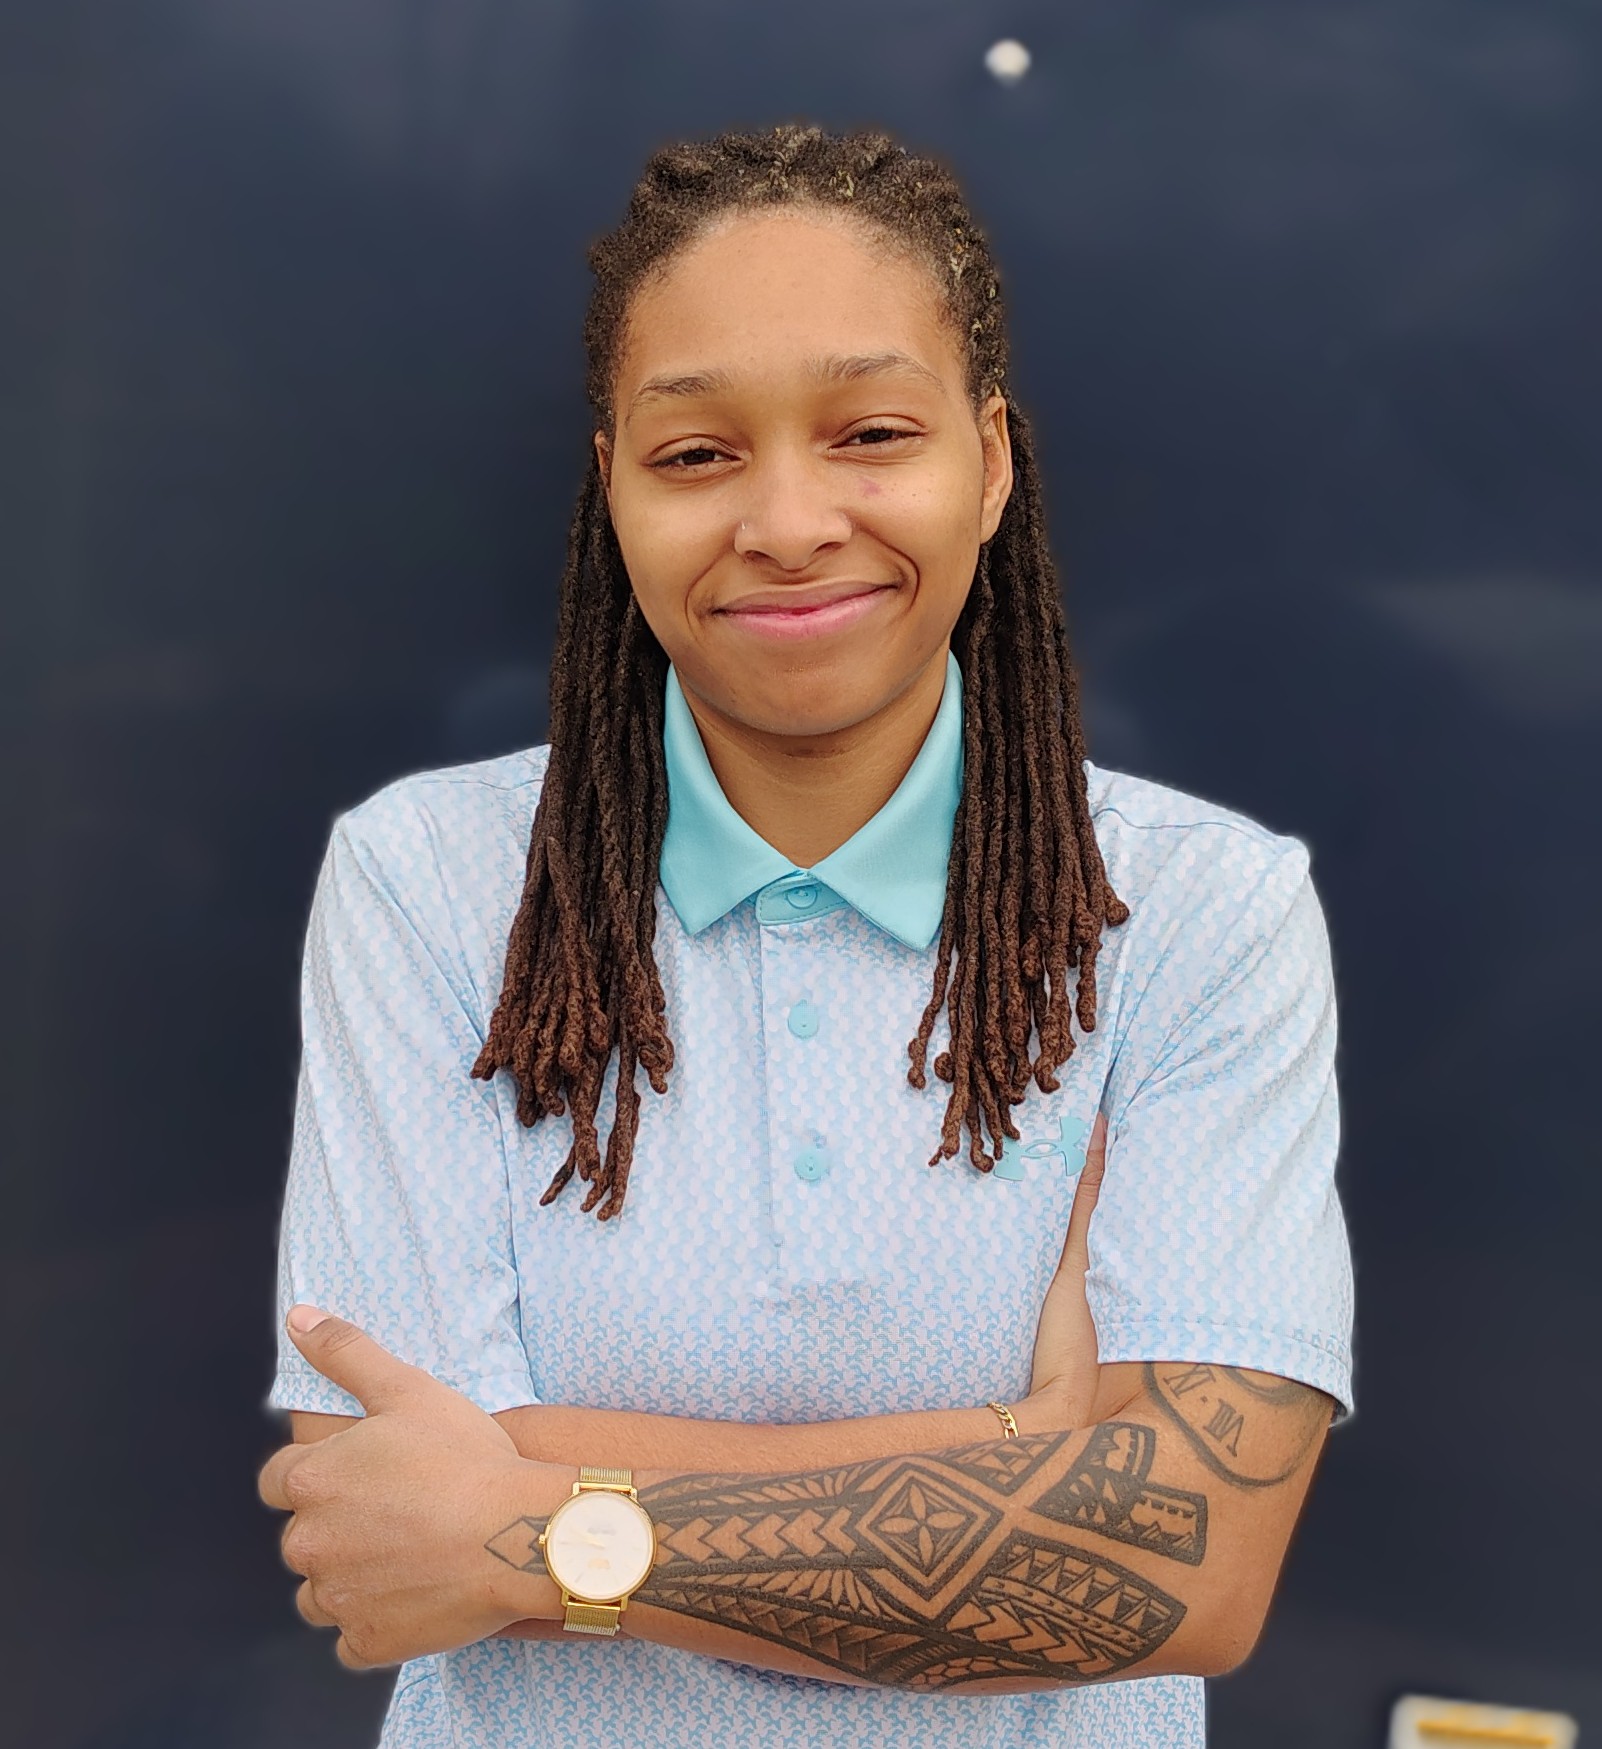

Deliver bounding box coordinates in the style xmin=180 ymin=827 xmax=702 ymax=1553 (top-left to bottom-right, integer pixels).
xmin=0 ymin=0 xmax=1602 ymax=1749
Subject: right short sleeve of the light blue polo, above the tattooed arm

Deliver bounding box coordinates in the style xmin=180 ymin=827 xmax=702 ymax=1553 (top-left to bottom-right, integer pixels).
xmin=1086 ymin=827 xmax=1354 ymax=1420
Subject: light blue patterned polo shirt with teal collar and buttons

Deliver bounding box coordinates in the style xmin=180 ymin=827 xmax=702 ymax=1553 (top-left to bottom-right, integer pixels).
xmin=268 ymin=658 xmax=1352 ymax=1749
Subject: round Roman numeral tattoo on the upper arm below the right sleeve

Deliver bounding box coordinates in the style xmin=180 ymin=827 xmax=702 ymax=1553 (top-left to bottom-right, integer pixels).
xmin=1146 ymin=1361 xmax=1334 ymax=1488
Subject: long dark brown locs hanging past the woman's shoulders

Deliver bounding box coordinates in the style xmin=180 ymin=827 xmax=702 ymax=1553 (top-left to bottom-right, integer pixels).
xmin=472 ymin=124 xmax=1130 ymax=1221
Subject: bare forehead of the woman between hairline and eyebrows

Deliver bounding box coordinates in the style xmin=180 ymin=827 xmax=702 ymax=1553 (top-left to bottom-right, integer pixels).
xmin=617 ymin=210 xmax=964 ymax=404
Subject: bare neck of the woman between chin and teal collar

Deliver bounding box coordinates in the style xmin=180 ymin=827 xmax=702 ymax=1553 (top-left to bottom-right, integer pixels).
xmin=680 ymin=645 xmax=946 ymax=869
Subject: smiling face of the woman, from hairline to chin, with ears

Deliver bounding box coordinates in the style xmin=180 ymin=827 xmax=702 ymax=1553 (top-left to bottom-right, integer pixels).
xmin=595 ymin=210 xmax=1013 ymax=738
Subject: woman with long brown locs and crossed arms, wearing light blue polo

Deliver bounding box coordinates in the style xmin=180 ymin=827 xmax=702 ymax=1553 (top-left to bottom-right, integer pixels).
xmin=261 ymin=128 xmax=1352 ymax=1749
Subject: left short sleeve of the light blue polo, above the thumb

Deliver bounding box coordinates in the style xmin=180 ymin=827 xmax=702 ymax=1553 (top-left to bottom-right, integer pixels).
xmin=266 ymin=787 xmax=539 ymax=1415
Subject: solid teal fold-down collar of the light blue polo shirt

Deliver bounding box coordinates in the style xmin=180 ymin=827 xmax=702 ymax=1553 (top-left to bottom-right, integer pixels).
xmin=659 ymin=651 xmax=962 ymax=948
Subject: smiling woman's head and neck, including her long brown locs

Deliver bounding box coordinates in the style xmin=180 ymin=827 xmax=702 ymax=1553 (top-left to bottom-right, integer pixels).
xmin=474 ymin=128 xmax=1130 ymax=1221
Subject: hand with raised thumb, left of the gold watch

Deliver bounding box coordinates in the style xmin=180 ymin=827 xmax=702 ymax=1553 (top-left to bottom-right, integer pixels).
xmin=257 ymin=1313 xmax=570 ymax=1670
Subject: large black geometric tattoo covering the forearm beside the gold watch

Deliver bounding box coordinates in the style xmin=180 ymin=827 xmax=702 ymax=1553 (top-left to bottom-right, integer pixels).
xmin=622 ymin=1425 xmax=1205 ymax=1690
